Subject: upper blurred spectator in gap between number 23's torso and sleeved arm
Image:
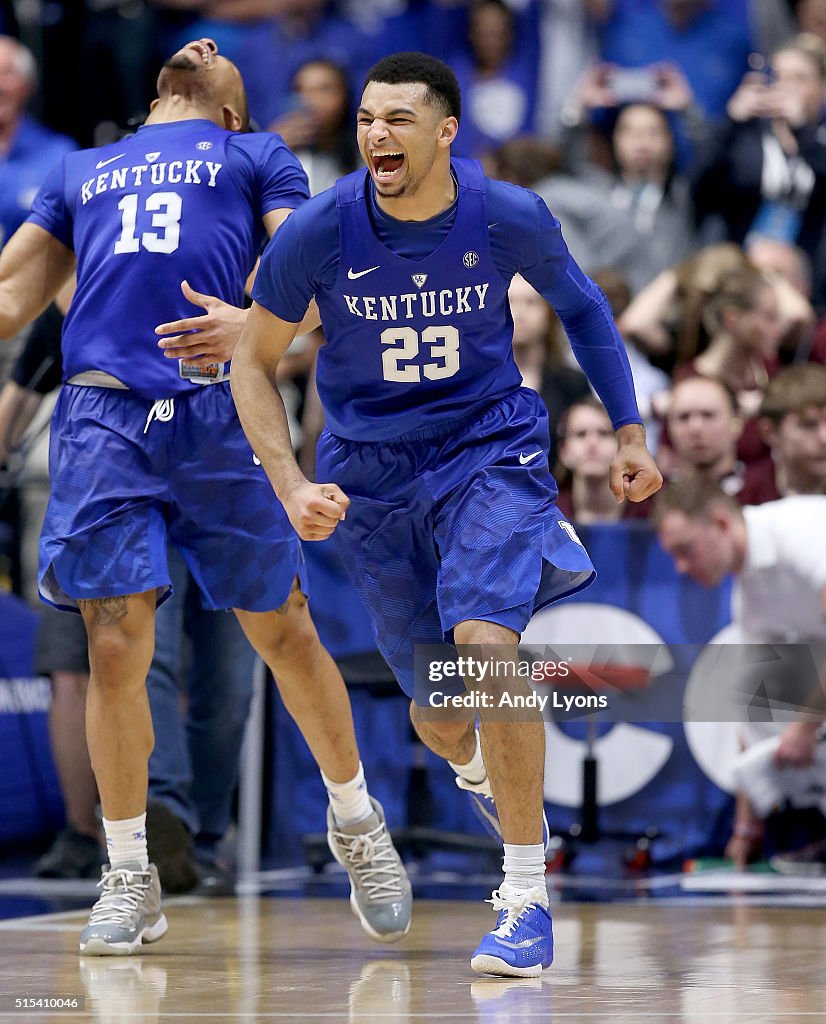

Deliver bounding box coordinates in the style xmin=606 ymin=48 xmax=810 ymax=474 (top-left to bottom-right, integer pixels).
xmin=508 ymin=274 xmax=589 ymax=467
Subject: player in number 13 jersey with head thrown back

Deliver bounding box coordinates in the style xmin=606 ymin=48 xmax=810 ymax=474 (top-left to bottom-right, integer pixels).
xmin=0 ymin=39 xmax=410 ymax=955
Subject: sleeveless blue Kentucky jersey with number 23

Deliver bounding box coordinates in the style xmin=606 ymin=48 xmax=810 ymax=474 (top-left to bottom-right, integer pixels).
xmin=316 ymin=160 xmax=521 ymax=440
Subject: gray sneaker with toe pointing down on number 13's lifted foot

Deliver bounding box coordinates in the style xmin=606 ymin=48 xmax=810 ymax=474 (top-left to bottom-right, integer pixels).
xmin=327 ymin=798 xmax=412 ymax=942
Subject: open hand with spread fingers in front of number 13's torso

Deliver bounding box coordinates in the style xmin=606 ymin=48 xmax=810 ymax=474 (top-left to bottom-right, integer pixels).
xmin=155 ymin=281 xmax=247 ymax=367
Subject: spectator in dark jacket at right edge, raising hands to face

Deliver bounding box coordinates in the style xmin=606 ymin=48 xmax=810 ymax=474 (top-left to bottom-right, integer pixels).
xmin=694 ymin=36 xmax=826 ymax=302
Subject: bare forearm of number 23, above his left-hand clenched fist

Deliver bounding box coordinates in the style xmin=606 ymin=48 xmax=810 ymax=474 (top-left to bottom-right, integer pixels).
xmin=230 ymin=339 xmax=307 ymax=502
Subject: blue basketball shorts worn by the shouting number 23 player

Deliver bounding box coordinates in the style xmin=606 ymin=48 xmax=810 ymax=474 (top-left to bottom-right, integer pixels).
xmin=316 ymin=388 xmax=596 ymax=695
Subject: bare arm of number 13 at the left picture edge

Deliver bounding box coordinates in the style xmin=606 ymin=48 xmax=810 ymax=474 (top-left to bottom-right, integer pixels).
xmin=0 ymin=222 xmax=75 ymax=337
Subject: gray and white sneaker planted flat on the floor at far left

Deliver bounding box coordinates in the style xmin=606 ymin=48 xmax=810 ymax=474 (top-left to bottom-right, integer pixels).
xmin=80 ymin=861 xmax=169 ymax=956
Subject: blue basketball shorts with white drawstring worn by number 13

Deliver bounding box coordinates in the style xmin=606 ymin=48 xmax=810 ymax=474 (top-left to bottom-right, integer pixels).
xmin=39 ymin=383 xmax=307 ymax=611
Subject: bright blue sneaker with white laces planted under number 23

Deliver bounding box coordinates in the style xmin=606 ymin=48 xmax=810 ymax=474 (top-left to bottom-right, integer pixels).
xmin=471 ymin=886 xmax=554 ymax=978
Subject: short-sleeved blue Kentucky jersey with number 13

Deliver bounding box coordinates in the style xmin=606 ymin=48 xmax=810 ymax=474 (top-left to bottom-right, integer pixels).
xmin=30 ymin=119 xmax=309 ymax=398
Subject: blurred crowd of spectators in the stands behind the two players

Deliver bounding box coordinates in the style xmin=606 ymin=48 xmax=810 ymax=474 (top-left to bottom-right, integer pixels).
xmin=0 ymin=0 xmax=826 ymax=512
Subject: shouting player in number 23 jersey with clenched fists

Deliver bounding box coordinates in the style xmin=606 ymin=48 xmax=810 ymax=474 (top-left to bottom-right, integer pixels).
xmin=232 ymin=53 xmax=661 ymax=976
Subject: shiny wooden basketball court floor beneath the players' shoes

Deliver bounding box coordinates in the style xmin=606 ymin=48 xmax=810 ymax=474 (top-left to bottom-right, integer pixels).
xmin=0 ymin=876 xmax=826 ymax=1024
